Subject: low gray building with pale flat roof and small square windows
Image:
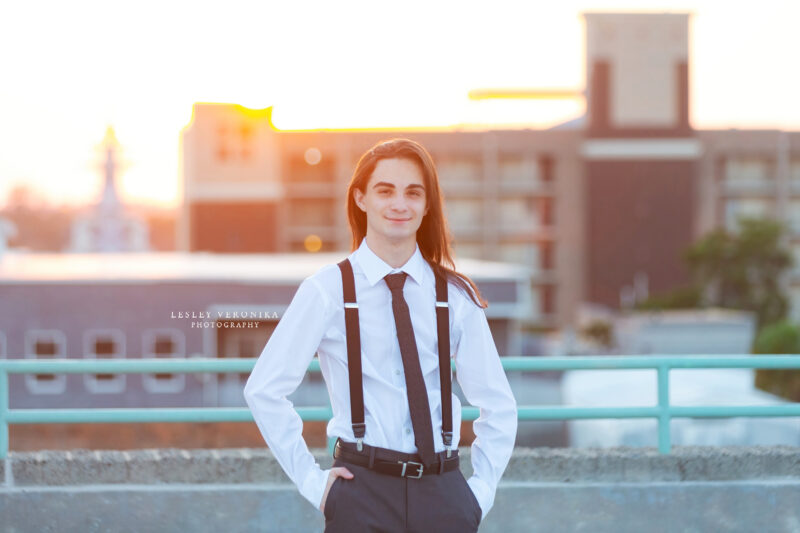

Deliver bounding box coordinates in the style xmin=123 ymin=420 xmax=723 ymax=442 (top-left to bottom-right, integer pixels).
xmin=0 ymin=250 xmax=530 ymax=409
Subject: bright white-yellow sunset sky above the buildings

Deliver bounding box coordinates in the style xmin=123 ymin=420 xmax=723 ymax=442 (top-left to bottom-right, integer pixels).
xmin=0 ymin=0 xmax=800 ymax=206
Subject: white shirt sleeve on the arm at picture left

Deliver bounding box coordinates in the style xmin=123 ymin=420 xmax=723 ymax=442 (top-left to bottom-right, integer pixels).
xmin=244 ymin=278 xmax=333 ymax=510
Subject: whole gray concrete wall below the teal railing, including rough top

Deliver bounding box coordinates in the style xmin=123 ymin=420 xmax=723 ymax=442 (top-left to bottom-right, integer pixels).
xmin=0 ymin=446 xmax=800 ymax=533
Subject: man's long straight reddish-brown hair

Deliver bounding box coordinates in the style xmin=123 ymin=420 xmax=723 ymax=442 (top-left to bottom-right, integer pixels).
xmin=347 ymin=139 xmax=489 ymax=308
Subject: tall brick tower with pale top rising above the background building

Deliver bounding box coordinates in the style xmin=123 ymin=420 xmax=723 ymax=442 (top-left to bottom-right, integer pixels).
xmin=581 ymin=13 xmax=701 ymax=308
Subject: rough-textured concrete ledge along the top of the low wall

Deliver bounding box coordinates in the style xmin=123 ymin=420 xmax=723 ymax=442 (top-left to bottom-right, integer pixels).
xmin=0 ymin=446 xmax=800 ymax=487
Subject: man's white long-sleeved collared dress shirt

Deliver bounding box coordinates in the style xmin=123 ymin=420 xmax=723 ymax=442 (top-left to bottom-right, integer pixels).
xmin=244 ymin=239 xmax=517 ymax=516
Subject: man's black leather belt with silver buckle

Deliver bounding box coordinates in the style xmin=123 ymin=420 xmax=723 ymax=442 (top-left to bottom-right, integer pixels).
xmin=333 ymin=439 xmax=459 ymax=479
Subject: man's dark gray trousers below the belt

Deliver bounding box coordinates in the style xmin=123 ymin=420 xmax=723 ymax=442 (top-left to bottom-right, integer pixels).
xmin=325 ymin=459 xmax=481 ymax=533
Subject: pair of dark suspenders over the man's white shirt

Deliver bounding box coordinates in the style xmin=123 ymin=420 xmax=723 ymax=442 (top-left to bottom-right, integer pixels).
xmin=338 ymin=258 xmax=453 ymax=457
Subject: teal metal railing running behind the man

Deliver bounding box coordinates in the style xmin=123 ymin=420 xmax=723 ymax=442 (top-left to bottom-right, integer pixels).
xmin=0 ymin=355 xmax=800 ymax=459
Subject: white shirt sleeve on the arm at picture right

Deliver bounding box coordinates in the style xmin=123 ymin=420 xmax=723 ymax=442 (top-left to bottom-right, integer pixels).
xmin=455 ymin=301 xmax=517 ymax=516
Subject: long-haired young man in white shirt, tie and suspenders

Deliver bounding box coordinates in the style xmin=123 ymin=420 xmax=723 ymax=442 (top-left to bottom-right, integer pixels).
xmin=244 ymin=139 xmax=517 ymax=533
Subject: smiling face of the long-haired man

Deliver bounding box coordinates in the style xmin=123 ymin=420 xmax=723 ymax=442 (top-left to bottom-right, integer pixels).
xmin=353 ymin=158 xmax=427 ymax=243
